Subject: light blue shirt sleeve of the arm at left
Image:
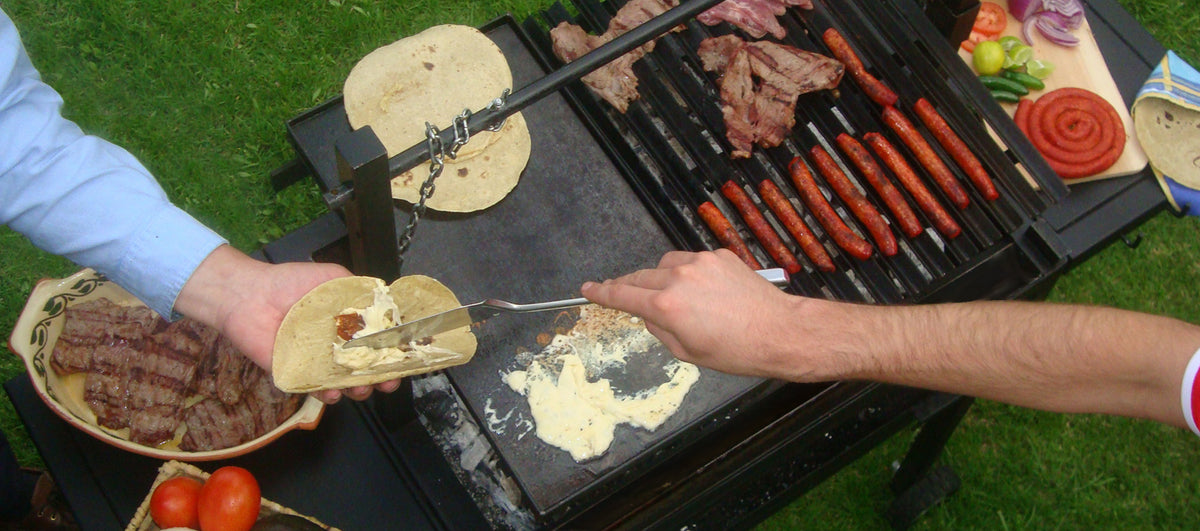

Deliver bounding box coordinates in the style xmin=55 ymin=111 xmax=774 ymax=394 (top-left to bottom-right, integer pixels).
xmin=0 ymin=11 xmax=226 ymax=318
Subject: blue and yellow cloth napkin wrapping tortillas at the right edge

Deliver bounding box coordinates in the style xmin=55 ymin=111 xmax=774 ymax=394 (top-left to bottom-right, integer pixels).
xmin=1130 ymin=50 xmax=1200 ymax=216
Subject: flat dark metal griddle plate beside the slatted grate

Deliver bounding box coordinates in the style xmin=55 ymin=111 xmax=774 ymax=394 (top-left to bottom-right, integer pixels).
xmin=288 ymin=17 xmax=763 ymax=518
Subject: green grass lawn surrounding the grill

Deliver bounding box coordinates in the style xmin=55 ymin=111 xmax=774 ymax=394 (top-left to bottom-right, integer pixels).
xmin=0 ymin=0 xmax=1200 ymax=529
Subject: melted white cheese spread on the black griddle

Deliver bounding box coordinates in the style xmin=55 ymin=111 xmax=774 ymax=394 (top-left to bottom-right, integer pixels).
xmin=504 ymin=306 xmax=700 ymax=461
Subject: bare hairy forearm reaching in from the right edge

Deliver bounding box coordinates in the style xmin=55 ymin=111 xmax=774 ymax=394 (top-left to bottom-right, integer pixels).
xmin=825 ymin=302 xmax=1200 ymax=425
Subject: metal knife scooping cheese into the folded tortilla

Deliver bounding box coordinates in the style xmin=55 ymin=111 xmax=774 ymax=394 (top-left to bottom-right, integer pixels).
xmin=342 ymin=268 xmax=787 ymax=348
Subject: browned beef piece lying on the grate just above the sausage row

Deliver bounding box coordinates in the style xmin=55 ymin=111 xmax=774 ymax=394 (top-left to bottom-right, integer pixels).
xmin=697 ymin=35 xmax=845 ymax=159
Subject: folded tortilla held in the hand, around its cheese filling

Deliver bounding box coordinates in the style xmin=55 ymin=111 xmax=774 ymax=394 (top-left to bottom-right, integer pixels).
xmin=271 ymin=275 xmax=476 ymax=393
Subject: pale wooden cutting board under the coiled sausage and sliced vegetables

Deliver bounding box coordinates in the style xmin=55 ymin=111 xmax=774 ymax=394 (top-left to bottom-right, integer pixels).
xmin=959 ymin=0 xmax=1148 ymax=184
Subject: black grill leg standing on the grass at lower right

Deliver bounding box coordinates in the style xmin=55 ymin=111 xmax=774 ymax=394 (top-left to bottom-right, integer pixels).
xmin=888 ymin=393 xmax=974 ymax=529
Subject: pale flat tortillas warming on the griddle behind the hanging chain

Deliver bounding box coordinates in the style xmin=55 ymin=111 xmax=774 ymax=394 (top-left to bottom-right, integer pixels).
xmin=343 ymin=24 xmax=532 ymax=213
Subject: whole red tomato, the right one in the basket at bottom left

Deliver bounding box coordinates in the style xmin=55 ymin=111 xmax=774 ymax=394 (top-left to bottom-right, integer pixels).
xmin=197 ymin=466 xmax=263 ymax=531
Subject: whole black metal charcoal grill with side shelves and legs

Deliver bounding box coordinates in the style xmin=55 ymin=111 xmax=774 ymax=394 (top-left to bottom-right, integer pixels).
xmin=7 ymin=0 xmax=1165 ymax=529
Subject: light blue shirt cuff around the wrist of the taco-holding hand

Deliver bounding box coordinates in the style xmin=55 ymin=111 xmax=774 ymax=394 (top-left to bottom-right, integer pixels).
xmin=101 ymin=203 xmax=227 ymax=321
